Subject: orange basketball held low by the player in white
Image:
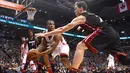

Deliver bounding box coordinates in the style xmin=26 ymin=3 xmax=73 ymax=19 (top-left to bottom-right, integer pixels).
xmin=27 ymin=49 xmax=40 ymax=61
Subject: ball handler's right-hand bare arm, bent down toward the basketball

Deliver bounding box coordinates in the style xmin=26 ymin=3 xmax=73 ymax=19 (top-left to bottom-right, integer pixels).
xmin=41 ymin=35 xmax=61 ymax=55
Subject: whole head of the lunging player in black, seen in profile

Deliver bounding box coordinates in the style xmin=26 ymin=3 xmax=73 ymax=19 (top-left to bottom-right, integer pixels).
xmin=74 ymin=1 xmax=87 ymax=16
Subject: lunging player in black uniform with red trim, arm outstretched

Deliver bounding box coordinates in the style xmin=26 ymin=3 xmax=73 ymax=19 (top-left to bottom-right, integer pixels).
xmin=35 ymin=1 xmax=130 ymax=73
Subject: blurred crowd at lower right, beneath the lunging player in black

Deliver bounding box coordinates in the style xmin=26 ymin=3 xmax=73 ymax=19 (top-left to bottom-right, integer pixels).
xmin=80 ymin=52 xmax=130 ymax=73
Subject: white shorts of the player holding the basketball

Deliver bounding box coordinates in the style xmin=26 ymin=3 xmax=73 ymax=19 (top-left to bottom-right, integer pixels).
xmin=52 ymin=44 xmax=70 ymax=58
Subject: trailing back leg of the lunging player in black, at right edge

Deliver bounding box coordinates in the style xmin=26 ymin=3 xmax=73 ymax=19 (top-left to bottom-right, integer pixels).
xmin=106 ymin=39 xmax=130 ymax=65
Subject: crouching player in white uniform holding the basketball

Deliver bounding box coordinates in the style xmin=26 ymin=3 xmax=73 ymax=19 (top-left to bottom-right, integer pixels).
xmin=29 ymin=20 xmax=71 ymax=73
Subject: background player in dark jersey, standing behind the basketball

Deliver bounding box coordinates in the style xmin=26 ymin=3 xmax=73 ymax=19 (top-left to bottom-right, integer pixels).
xmin=22 ymin=30 xmax=38 ymax=73
